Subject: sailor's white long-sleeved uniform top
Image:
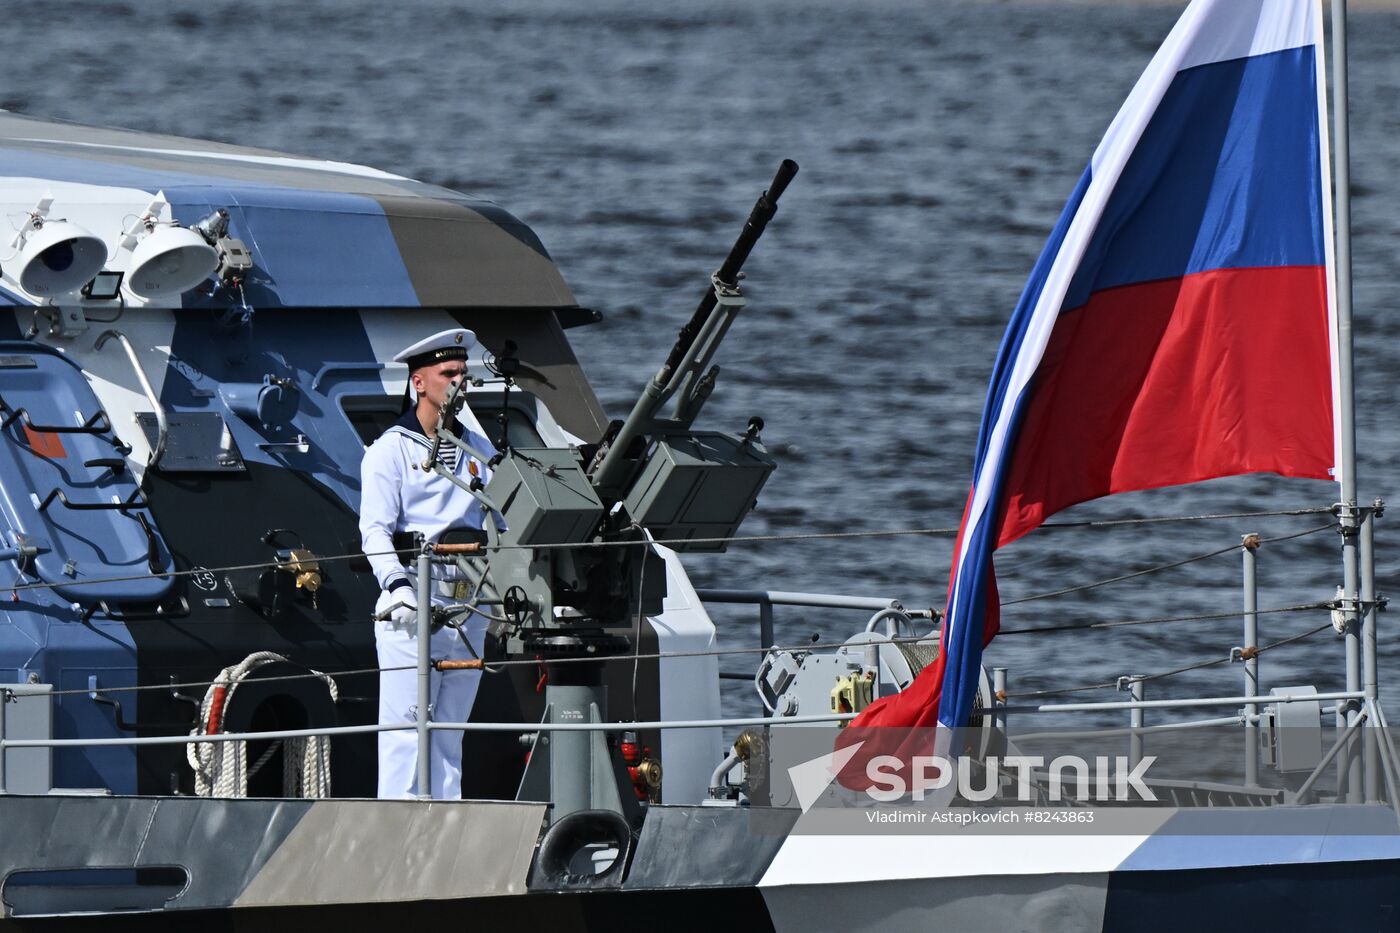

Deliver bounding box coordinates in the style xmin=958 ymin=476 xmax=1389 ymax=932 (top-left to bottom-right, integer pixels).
xmin=360 ymin=409 xmax=496 ymax=590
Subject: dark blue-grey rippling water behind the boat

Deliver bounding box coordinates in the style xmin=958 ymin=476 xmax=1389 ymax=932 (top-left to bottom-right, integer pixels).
xmin=0 ymin=0 xmax=1400 ymax=710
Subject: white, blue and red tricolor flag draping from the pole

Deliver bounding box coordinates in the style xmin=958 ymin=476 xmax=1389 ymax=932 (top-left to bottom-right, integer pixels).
xmin=843 ymin=0 xmax=1337 ymax=744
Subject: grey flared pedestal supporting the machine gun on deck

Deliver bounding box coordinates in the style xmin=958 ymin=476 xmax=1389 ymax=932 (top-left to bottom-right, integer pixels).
xmin=515 ymin=630 xmax=640 ymax=825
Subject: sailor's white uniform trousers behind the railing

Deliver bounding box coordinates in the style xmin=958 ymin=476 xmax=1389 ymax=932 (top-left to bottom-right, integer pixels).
xmin=374 ymin=597 xmax=486 ymax=800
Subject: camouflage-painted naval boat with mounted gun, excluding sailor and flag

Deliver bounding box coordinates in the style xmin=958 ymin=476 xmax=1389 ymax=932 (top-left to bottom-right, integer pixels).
xmin=0 ymin=0 xmax=1400 ymax=933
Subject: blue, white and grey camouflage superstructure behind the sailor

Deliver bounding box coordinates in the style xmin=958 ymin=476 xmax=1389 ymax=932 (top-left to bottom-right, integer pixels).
xmin=0 ymin=115 xmax=677 ymax=796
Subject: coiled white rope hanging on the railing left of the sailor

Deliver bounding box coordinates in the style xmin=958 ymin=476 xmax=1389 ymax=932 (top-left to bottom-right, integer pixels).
xmin=186 ymin=651 xmax=339 ymax=799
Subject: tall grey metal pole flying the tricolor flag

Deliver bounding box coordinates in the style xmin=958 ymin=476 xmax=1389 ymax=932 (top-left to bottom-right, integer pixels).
xmin=1331 ymin=0 xmax=1373 ymax=801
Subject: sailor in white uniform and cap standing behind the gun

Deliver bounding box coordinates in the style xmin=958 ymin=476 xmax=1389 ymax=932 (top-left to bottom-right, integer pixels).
xmin=360 ymin=329 xmax=496 ymax=800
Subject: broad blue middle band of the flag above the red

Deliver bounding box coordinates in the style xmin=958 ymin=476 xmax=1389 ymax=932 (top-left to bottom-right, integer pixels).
xmin=1064 ymin=46 xmax=1326 ymax=310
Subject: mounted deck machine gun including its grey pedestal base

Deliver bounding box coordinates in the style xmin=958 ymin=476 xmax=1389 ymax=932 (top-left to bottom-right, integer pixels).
xmin=423 ymin=160 xmax=798 ymax=817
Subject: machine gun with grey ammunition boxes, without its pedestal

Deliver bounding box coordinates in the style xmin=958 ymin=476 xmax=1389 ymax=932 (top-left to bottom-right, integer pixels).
xmin=464 ymin=160 xmax=798 ymax=636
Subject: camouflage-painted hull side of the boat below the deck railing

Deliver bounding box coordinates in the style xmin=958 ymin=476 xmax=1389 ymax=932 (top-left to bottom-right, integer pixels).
xmin=0 ymin=796 xmax=1400 ymax=933
